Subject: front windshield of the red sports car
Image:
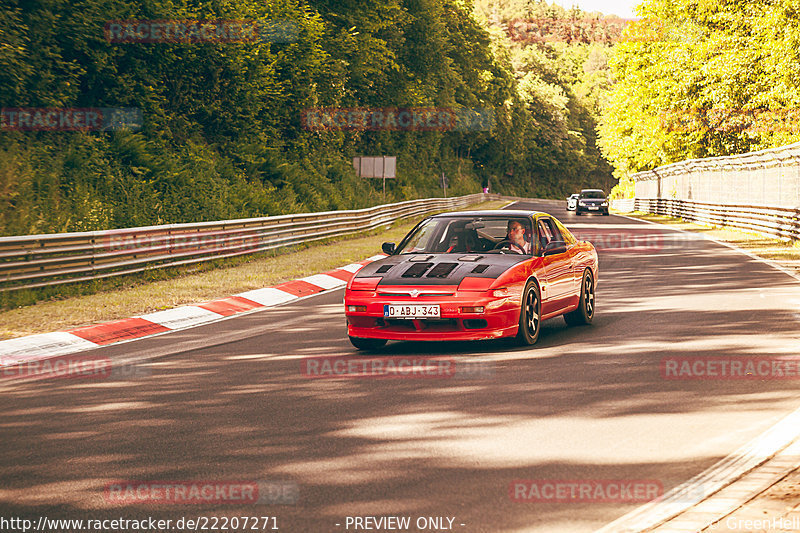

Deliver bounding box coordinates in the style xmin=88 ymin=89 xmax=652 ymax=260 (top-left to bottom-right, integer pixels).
xmin=397 ymin=216 xmax=531 ymax=254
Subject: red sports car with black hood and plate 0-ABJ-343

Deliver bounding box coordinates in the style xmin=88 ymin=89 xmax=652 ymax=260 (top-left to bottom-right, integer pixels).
xmin=344 ymin=211 xmax=598 ymax=350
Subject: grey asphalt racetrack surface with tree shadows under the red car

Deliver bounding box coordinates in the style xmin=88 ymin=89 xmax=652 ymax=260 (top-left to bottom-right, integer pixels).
xmin=0 ymin=201 xmax=800 ymax=532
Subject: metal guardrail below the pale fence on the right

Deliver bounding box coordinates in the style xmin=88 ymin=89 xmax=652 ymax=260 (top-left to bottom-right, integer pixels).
xmin=635 ymin=198 xmax=800 ymax=239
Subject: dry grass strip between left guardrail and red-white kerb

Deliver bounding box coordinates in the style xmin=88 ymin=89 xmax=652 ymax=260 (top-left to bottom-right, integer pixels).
xmin=0 ymin=197 xmax=508 ymax=340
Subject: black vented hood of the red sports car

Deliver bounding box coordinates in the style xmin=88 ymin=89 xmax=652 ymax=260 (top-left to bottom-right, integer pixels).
xmin=356 ymin=253 xmax=531 ymax=285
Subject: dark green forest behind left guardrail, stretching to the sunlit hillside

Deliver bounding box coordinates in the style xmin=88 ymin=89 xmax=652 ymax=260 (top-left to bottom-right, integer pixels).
xmin=0 ymin=0 xmax=611 ymax=235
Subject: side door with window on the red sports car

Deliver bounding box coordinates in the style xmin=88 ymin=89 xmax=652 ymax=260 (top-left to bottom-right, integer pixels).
xmin=536 ymin=217 xmax=575 ymax=315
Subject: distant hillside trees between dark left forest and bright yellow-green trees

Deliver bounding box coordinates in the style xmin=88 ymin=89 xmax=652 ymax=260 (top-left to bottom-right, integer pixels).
xmin=476 ymin=0 xmax=621 ymax=197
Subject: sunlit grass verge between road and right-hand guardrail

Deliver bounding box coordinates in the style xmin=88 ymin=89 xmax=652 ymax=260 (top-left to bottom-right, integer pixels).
xmin=615 ymin=211 xmax=800 ymax=275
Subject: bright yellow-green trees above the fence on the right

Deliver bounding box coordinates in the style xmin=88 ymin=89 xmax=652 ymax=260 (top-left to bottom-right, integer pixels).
xmin=601 ymin=0 xmax=800 ymax=191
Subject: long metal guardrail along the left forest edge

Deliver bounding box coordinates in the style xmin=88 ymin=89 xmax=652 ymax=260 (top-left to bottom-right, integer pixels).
xmin=0 ymin=193 xmax=500 ymax=291
